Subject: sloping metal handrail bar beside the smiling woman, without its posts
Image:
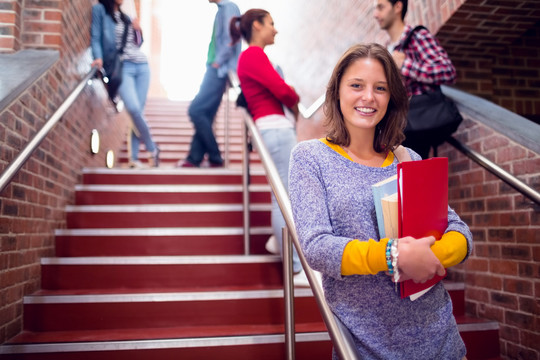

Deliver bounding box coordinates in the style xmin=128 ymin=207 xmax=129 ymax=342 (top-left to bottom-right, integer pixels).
xmin=229 ymin=71 xmax=359 ymax=360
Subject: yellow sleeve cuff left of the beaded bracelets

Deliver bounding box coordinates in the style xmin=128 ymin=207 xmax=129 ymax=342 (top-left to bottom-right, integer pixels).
xmin=341 ymin=238 xmax=388 ymax=276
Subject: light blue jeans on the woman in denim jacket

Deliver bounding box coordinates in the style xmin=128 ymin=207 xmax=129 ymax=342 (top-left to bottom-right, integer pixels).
xmin=118 ymin=61 xmax=156 ymax=160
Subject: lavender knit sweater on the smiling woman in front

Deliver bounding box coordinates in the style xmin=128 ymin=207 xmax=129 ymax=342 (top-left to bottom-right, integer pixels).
xmin=289 ymin=140 xmax=472 ymax=360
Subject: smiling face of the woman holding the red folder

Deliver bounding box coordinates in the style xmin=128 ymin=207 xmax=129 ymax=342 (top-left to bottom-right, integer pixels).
xmin=339 ymin=58 xmax=390 ymax=135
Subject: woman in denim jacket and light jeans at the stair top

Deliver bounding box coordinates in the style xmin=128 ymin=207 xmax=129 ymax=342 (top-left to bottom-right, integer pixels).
xmin=91 ymin=0 xmax=159 ymax=167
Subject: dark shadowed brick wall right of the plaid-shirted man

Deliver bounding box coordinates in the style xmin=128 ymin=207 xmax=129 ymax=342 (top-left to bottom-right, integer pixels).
xmin=437 ymin=0 xmax=540 ymax=124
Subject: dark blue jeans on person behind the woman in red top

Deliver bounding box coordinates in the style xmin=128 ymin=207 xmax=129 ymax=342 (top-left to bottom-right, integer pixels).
xmin=187 ymin=65 xmax=227 ymax=166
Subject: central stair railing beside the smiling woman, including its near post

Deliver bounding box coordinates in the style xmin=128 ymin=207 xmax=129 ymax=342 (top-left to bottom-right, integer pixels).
xmin=229 ymin=71 xmax=359 ymax=360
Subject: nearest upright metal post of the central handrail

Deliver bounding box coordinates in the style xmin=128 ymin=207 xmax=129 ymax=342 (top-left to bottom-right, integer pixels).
xmin=282 ymin=227 xmax=296 ymax=360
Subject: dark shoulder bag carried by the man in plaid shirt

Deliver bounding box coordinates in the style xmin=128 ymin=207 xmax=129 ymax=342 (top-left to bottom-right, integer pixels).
xmin=402 ymin=26 xmax=463 ymax=146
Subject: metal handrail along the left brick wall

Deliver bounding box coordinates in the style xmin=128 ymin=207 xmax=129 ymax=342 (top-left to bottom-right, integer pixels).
xmin=0 ymin=68 xmax=97 ymax=192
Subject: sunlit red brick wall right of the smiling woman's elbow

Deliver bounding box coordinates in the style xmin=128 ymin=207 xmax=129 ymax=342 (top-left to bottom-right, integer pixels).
xmin=439 ymin=118 xmax=540 ymax=359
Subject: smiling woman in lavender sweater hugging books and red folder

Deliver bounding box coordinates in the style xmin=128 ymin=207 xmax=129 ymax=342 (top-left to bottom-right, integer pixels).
xmin=289 ymin=44 xmax=472 ymax=360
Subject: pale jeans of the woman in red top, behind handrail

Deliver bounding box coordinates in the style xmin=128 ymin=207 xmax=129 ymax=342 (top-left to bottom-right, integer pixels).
xmin=260 ymin=128 xmax=302 ymax=273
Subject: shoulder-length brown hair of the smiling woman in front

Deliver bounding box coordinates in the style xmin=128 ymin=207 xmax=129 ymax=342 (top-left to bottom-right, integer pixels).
xmin=324 ymin=43 xmax=409 ymax=153
